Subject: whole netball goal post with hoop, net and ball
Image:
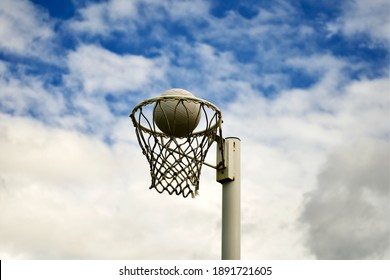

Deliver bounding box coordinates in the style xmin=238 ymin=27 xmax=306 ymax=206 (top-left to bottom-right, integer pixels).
xmin=130 ymin=89 xmax=241 ymax=260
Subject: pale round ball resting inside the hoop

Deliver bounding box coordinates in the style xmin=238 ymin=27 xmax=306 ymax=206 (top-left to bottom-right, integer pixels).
xmin=153 ymin=88 xmax=200 ymax=137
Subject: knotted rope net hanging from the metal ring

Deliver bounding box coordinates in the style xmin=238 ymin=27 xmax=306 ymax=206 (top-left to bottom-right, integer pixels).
xmin=130 ymin=96 xmax=222 ymax=197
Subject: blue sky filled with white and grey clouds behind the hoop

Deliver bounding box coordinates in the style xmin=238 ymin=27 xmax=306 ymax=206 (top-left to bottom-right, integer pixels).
xmin=0 ymin=0 xmax=390 ymax=260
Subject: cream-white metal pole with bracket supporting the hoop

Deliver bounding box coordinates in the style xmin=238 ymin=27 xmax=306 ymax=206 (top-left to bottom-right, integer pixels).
xmin=217 ymin=137 xmax=241 ymax=260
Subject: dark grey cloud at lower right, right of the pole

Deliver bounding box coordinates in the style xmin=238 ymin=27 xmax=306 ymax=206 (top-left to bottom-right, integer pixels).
xmin=301 ymin=140 xmax=390 ymax=259
